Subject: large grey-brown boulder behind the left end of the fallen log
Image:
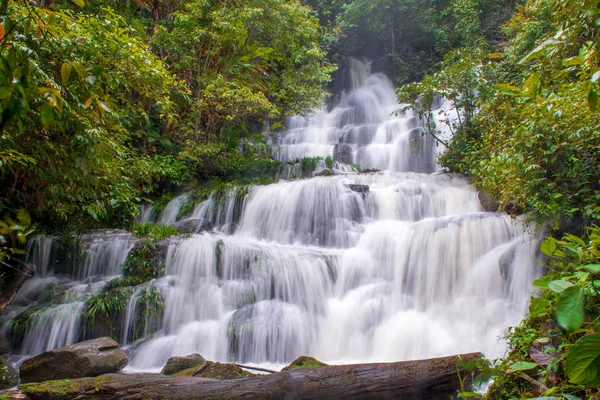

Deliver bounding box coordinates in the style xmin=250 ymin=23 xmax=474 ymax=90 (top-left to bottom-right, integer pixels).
xmin=21 ymin=337 xmax=128 ymax=383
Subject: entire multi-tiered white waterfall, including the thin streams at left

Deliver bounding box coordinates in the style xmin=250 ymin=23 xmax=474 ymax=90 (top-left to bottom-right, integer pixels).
xmin=3 ymin=61 xmax=537 ymax=370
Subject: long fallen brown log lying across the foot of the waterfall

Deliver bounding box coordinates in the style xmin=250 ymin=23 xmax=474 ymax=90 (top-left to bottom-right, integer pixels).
xmin=9 ymin=353 xmax=481 ymax=400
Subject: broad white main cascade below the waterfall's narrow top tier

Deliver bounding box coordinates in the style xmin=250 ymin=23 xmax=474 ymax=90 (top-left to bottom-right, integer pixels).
xmin=130 ymin=172 xmax=535 ymax=369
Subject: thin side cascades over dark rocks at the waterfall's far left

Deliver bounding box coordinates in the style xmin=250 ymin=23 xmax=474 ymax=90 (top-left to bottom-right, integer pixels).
xmin=2 ymin=231 xmax=134 ymax=355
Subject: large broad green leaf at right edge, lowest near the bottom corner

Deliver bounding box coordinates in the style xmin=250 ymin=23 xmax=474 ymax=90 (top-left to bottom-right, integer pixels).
xmin=567 ymin=333 xmax=600 ymax=386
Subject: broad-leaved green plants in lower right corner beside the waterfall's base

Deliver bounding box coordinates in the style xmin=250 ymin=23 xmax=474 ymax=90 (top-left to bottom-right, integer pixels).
xmin=488 ymin=227 xmax=600 ymax=399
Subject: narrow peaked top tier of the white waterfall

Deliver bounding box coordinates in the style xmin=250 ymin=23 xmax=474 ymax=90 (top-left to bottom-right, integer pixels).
xmin=273 ymin=59 xmax=436 ymax=172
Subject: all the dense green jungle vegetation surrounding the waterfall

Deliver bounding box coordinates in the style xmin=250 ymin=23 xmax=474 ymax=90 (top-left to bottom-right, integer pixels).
xmin=0 ymin=0 xmax=600 ymax=400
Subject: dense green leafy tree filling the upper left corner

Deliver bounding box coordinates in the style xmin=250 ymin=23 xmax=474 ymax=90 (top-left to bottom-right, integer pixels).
xmin=0 ymin=2 xmax=179 ymax=225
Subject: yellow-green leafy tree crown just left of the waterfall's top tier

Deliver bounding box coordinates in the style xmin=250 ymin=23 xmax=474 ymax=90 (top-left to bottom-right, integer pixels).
xmin=153 ymin=0 xmax=332 ymax=143
